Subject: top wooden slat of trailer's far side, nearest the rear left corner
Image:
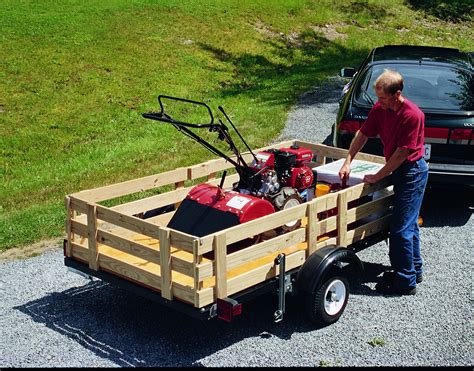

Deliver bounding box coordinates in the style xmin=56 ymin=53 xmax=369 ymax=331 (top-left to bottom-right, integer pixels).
xmin=73 ymin=168 xmax=188 ymax=202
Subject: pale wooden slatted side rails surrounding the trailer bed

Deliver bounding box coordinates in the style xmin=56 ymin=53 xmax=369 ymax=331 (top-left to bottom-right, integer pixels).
xmin=65 ymin=141 xmax=393 ymax=308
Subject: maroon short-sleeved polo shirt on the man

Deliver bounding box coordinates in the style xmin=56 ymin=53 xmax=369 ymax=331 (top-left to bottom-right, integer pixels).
xmin=360 ymin=98 xmax=425 ymax=162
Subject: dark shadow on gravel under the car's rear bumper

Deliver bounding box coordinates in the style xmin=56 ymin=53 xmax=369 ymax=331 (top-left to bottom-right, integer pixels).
xmin=420 ymin=187 xmax=474 ymax=228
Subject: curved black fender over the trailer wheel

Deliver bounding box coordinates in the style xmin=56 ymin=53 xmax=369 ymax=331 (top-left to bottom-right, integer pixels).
xmin=296 ymin=245 xmax=364 ymax=293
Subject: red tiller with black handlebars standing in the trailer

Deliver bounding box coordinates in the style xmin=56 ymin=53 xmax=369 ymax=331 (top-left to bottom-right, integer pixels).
xmin=143 ymin=95 xmax=315 ymax=237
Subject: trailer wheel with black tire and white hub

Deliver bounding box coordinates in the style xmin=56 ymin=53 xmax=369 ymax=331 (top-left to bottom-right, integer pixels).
xmin=306 ymin=275 xmax=349 ymax=327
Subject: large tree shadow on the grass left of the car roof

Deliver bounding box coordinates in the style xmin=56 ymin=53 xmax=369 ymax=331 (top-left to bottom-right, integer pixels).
xmin=194 ymin=29 xmax=369 ymax=106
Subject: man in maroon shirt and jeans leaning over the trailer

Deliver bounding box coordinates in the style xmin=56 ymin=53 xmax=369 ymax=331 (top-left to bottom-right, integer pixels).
xmin=339 ymin=70 xmax=428 ymax=295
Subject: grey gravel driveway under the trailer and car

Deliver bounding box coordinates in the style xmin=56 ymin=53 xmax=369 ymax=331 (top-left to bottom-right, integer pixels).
xmin=0 ymin=78 xmax=474 ymax=367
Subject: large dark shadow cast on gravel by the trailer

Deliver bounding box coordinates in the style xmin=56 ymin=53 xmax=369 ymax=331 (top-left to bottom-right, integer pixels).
xmin=14 ymin=281 xmax=318 ymax=367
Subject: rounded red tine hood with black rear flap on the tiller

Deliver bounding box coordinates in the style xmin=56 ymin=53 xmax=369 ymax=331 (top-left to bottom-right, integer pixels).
xmin=168 ymin=183 xmax=275 ymax=237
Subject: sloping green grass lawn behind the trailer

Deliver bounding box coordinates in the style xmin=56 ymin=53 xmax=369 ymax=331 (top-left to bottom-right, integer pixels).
xmin=0 ymin=0 xmax=474 ymax=251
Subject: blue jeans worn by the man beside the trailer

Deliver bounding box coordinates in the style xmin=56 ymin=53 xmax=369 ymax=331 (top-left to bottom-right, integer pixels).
xmin=389 ymin=158 xmax=428 ymax=288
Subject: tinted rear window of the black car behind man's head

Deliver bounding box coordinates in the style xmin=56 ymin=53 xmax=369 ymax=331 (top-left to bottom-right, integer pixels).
xmin=355 ymin=64 xmax=474 ymax=111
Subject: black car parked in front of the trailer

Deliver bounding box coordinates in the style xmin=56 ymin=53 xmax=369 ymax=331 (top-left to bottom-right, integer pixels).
xmin=333 ymin=45 xmax=474 ymax=186
